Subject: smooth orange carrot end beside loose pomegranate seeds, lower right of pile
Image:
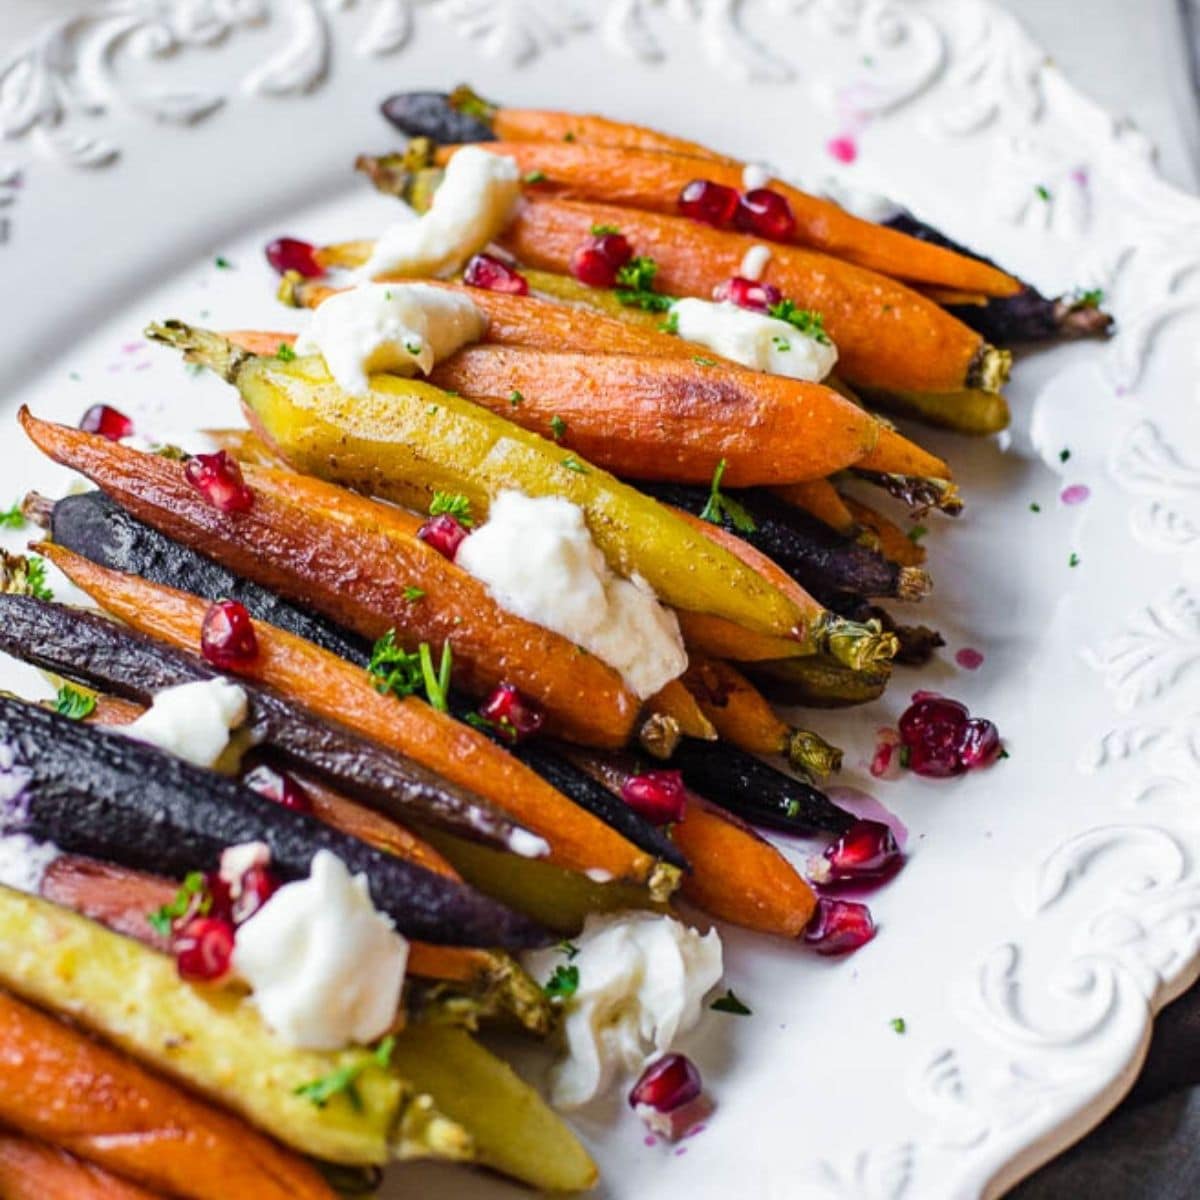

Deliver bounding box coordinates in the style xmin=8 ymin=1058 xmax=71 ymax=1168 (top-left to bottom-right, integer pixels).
xmin=671 ymin=797 xmax=816 ymax=937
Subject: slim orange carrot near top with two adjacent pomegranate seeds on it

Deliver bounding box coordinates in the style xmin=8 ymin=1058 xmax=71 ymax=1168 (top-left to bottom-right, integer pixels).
xmin=434 ymin=139 xmax=1021 ymax=297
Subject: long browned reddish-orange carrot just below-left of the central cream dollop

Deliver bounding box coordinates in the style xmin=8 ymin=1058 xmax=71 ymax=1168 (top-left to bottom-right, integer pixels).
xmin=22 ymin=412 xmax=640 ymax=746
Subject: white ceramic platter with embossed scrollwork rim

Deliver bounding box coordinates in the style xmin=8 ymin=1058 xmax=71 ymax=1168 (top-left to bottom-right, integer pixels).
xmin=0 ymin=0 xmax=1200 ymax=1200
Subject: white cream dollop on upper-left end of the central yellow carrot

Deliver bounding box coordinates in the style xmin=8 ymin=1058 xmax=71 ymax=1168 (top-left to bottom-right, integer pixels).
xmin=296 ymin=283 xmax=487 ymax=396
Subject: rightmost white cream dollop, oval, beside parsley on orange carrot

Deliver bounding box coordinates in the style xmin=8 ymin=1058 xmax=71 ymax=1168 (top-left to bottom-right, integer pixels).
xmin=671 ymin=296 xmax=838 ymax=383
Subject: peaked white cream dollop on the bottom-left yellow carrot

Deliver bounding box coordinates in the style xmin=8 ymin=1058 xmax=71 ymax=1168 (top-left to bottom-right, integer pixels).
xmin=233 ymin=850 xmax=408 ymax=1050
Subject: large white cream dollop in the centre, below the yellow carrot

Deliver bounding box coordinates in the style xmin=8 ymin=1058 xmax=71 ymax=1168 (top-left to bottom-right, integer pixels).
xmin=455 ymin=492 xmax=688 ymax=700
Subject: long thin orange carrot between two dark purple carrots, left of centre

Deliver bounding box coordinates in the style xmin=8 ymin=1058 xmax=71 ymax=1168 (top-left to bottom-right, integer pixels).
xmin=38 ymin=544 xmax=678 ymax=890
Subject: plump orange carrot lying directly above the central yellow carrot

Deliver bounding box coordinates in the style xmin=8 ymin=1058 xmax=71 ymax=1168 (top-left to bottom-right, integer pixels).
xmin=430 ymin=347 xmax=880 ymax=486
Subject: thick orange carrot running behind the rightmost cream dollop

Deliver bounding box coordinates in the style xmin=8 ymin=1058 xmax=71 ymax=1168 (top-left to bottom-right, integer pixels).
xmin=500 ymin=197 xmax=983 ymax=392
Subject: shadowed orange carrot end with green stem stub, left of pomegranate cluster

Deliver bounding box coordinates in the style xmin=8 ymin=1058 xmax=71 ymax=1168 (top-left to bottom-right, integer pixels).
xmin=683 ymin=655 xmax=841 ymax=776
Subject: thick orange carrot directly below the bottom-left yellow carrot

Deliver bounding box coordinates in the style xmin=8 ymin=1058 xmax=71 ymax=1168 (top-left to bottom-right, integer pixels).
xmin=0 ymin=992 xmax=334 ymax=1200
